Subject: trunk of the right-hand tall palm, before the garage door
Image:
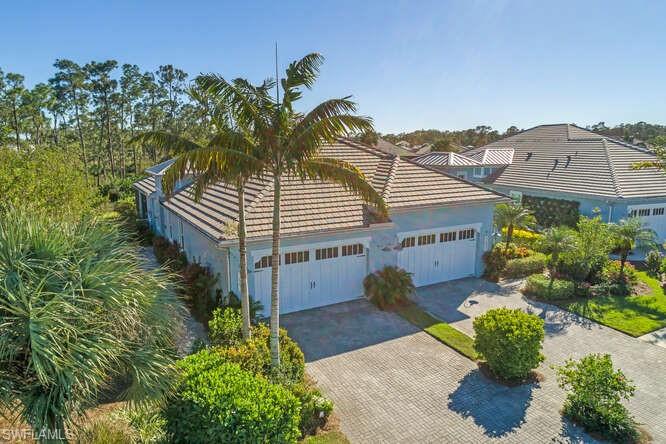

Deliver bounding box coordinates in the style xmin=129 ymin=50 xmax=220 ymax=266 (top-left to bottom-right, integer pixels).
xmin=270 ymin=171 xmax=280 ymax=370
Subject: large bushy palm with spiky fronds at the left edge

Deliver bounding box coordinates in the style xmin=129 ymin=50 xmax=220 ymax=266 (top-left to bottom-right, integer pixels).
xmin=0 ymin=209 xmax=180 ymax=442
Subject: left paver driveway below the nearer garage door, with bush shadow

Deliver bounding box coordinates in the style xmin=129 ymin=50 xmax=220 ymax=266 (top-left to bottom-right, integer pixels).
xmin=282 ymin=294 xmax=591 ymax=443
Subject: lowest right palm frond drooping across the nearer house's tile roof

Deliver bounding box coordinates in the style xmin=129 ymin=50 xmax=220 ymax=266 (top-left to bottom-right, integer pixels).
xmin=298 ymin=157 xmax=388 ymax=216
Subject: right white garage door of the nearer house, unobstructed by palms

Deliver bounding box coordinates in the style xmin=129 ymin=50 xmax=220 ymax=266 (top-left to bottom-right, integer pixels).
xmin=398 ymin=224 xmax=480 ymax=287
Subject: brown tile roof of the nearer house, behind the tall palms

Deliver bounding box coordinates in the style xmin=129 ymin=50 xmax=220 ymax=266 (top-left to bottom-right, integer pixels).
xmin=135 ymin=140 xmax=506 ymax=240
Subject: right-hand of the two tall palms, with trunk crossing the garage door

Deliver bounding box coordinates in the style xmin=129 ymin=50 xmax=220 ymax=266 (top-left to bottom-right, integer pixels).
xmin=199 ymin=53 xmax=387 ymax=369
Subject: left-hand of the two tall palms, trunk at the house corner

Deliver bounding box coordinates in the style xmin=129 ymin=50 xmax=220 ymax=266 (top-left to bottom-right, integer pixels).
xmin=132 ymin=85 xmax=270 ymax=339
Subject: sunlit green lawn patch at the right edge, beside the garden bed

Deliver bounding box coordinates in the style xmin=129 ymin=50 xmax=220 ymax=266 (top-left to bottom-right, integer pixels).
xmin=558 ymin=271 xmax=666 ymax=336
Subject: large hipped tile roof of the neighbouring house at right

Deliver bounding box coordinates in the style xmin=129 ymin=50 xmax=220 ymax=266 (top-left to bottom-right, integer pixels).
xmin=464 ymin=124 xmax=666 ymax=198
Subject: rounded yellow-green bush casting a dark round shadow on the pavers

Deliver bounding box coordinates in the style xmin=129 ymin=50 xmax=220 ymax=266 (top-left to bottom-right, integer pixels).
xmin=473 ymin=308 xmax=545 ymax=380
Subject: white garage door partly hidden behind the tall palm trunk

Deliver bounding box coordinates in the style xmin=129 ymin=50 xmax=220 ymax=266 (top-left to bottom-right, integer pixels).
xmin=251 ymin=238 xmax=368 ymax=316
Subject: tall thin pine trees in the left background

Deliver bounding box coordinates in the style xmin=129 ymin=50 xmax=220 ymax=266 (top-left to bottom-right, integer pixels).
xmin=0 ymin=59 xmax=207 ymax=184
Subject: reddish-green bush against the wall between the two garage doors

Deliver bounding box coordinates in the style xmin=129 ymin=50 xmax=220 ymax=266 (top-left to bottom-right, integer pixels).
xmin=363 ymin=266 xmax=414 ymax=310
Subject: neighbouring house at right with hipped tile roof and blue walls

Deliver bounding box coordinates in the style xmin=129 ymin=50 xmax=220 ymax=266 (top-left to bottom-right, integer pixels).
xmin=414 ymin=124 xmax=666 ymax=241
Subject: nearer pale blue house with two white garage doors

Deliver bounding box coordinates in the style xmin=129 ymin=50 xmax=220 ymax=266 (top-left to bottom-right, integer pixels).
xmin=134 ymin=140 xmax=509 ymax=314
